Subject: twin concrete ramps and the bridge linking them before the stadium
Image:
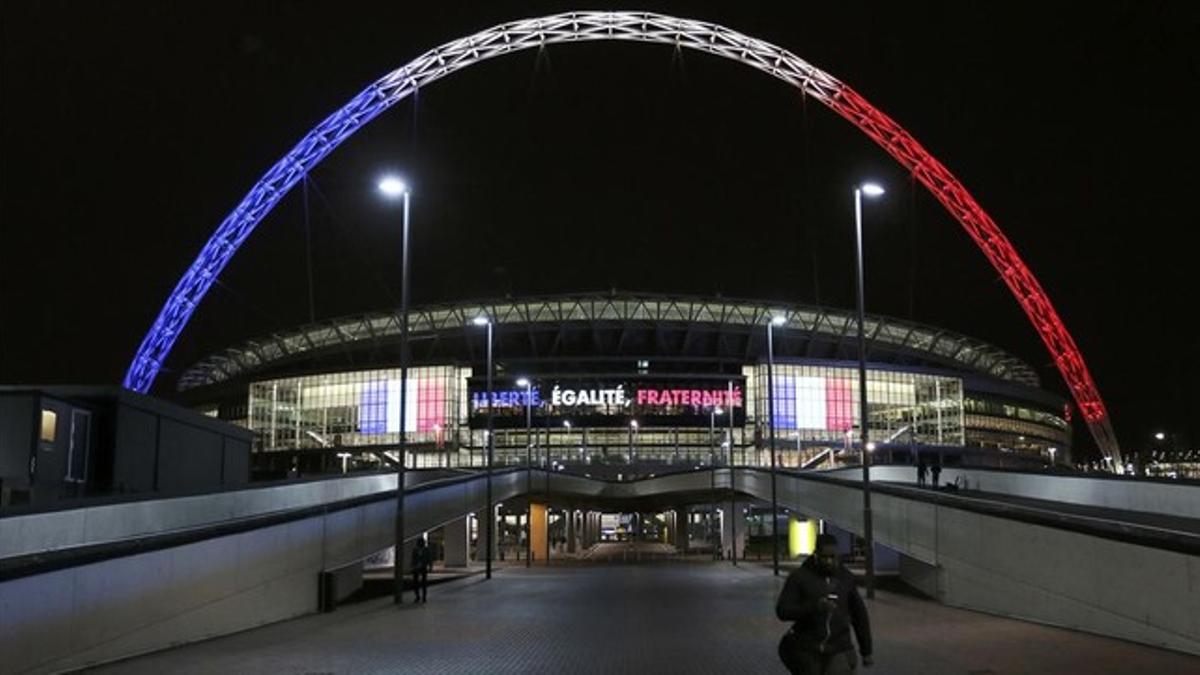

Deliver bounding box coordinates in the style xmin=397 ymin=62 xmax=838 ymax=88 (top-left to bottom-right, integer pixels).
xmin=0 ymin=468 xmax=1200 ymax=673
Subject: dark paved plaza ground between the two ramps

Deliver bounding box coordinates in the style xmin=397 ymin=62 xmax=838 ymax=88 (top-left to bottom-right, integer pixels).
xmin=96 ymin=562 xmax=1200 ymax=675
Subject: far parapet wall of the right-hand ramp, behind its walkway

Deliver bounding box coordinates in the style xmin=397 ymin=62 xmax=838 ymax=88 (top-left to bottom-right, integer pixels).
xmin=821 ymin=466 xmax=1200 ymax=518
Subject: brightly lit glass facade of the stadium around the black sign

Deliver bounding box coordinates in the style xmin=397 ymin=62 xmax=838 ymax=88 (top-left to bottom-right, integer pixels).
xmin=241 ymin=363 xmax=1070 ymax=468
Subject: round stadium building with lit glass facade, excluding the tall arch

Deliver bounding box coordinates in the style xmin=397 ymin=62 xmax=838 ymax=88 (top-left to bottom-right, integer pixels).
xmin=178 ymin=294 xmax=1072 ymax=478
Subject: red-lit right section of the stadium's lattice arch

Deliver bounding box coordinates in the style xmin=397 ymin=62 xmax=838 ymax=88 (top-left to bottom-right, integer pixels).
xmin=829 ymin=85 xmax=1116 ymax=450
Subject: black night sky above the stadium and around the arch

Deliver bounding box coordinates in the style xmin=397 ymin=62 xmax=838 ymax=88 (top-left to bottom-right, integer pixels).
xmin=0 ymin=1 xmax=1200 ymax=453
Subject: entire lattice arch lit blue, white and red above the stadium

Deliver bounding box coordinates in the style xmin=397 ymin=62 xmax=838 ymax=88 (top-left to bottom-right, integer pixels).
xmin=125 ymin=12 xmax=1121 ymax=467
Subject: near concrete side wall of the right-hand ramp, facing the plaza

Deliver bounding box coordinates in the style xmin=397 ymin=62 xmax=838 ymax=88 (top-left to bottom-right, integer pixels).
xmin=738 ymin=472 xmax=1200 ymax=655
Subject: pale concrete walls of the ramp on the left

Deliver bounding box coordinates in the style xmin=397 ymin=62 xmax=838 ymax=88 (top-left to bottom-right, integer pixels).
xmin=0 ymin=473 xmax=526 ymax=673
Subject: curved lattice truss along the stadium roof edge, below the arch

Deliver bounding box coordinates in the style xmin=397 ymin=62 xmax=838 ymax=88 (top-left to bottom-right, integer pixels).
xmin=178 ymin=295 xmax=1040 ymax=390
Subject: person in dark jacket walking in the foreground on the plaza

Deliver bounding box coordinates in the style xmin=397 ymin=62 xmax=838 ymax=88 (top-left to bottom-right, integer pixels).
xmin=775 ymin=534 xmax=874 ymax=675
